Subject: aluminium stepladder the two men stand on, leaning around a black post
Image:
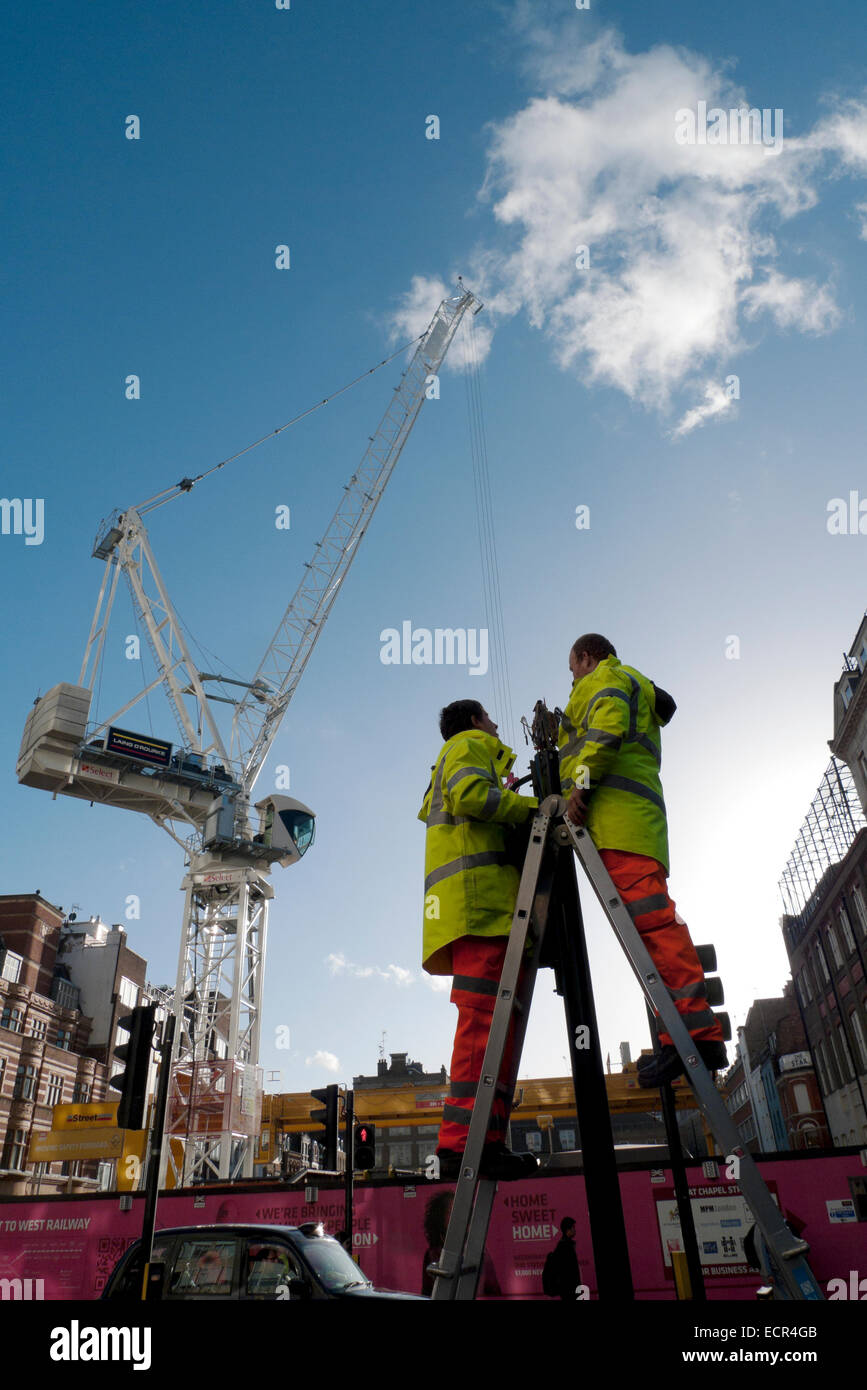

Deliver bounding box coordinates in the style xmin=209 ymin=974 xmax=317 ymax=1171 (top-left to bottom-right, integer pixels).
xmin=429 ymin=795 xmax=824 ymax=1301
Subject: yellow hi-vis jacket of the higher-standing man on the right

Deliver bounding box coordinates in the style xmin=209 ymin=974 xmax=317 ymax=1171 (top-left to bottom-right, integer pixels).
xmin=559 ymin=656 xmax=675 ymax=872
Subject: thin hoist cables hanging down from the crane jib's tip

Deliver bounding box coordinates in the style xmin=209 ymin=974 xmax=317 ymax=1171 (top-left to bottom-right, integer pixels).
xmin=465 ymin=317 xmax=515 ymax=748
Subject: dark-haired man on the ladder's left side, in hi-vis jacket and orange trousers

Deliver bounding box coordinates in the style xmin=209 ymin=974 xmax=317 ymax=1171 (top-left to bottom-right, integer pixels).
xmin=418 ymin=699 xmax=538 ymax=1180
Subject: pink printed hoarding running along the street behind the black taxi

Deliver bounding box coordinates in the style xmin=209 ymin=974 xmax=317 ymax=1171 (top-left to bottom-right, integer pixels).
xmin=0 ymin=1155 xmax=867 ymax=1300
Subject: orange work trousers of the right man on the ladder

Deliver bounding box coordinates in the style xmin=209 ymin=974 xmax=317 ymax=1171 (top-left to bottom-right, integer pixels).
xmin=599 ymin=849 xmax=723 ymax=1047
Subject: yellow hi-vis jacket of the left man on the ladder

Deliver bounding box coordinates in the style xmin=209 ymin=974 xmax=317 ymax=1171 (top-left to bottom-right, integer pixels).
xmin=418 ymin=728 xmax=538 ymax=974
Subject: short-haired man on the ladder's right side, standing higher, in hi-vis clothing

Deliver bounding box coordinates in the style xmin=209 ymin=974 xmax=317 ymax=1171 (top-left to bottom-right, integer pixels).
xmin=559 ymin=632 xmax=728 ymax=1087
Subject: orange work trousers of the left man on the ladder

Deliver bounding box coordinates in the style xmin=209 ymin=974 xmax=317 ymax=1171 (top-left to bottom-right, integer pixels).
xmin=438 ymin=937 xmax=515 ymax=1154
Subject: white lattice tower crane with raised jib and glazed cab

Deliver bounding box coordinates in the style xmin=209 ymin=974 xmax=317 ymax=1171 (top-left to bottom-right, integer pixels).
xmin=17 ymin=285 xmax=482 ymax=1183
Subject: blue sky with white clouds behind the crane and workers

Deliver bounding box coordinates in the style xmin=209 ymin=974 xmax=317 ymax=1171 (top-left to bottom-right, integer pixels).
xmin=0 ymin=0 xmax=867 ymax=1090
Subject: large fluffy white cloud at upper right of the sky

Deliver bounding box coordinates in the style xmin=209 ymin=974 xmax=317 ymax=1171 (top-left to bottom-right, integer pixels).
xmin=395 ymin=16 xmax=867 ymax=435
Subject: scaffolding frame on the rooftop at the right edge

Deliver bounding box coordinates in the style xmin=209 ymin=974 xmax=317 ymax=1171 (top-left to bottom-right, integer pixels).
xmin=778 ymin=758 xmax=867 ymax=930
